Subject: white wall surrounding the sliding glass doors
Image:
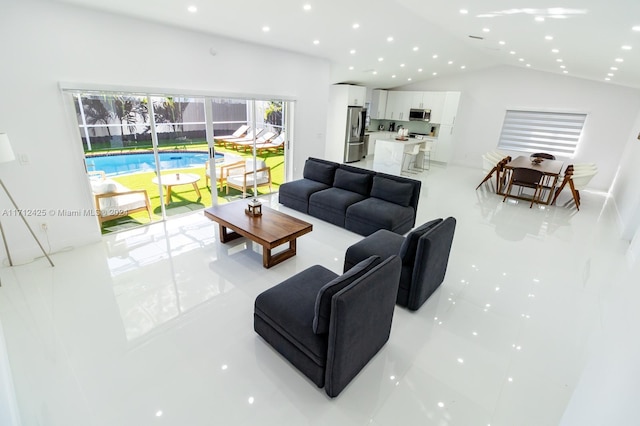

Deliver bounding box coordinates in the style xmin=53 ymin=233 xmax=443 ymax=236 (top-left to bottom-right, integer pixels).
xmin=0 ymin=0 xmax=330 ymax=261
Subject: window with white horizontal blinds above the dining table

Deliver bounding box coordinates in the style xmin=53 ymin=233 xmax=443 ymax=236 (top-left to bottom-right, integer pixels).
xmin=498 ymin=110 xmax=587 ymax=157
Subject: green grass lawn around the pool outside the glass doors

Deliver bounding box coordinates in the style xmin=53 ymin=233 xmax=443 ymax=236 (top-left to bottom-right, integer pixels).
xmin=96 ymin=144 xmax=284 ymax=234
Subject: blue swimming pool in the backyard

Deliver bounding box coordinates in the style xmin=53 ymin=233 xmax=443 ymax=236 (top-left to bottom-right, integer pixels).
xmin=85 ymin=152 xmax=219 ymax=175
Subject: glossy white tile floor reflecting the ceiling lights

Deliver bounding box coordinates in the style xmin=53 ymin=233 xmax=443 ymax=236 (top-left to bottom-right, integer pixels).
xmin=0 ymin=164 xmax=640 ymax=426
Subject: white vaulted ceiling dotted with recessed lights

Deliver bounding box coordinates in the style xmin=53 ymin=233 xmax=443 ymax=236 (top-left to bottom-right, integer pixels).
xmin=59 ymin=0 xmax=640 ymax=88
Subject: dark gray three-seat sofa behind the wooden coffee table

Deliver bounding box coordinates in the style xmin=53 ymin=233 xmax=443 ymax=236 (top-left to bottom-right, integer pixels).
xmin=279 ymin=158 xmax=421 ymax=236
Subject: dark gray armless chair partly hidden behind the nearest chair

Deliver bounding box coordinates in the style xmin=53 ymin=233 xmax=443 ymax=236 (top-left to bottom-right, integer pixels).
xmin=344 ymin=217 xmax=456 ymax=311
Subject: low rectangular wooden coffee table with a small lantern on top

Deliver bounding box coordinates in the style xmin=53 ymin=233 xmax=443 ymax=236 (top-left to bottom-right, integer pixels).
xmin=204 ymin=201 xmax=313 ymax=268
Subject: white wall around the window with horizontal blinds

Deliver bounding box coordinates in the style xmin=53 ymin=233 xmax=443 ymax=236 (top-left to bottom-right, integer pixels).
xmin=397 ymin=66 xmax=640 ymax=190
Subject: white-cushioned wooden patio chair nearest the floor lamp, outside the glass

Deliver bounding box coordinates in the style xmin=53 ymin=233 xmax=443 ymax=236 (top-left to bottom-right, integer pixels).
xmin=89 ymin=170 xmax=151 ymax=224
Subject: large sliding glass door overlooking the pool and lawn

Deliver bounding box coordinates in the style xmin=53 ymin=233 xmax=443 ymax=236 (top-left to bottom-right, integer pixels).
xmin=65 ymin=91 xmax=291 ymax=233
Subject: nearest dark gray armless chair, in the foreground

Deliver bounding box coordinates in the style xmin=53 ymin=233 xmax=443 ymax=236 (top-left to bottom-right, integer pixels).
xmin=254 ymin=256 xmax=401 ymax=397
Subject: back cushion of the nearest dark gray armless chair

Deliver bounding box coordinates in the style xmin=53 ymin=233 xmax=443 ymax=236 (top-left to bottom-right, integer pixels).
xmin=313 ymin=256 xmax=381 ymax=334
